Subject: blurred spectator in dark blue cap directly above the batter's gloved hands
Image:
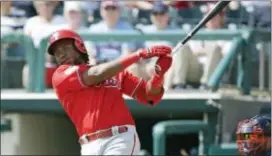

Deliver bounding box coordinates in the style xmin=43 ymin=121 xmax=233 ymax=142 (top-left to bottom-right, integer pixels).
xmin=128 ymin=3 xmax=180 ymax=83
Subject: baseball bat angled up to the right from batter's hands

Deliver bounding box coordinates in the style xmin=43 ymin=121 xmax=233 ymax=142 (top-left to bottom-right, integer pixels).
xmin=172 ymin=1 xmax=230 ymax=54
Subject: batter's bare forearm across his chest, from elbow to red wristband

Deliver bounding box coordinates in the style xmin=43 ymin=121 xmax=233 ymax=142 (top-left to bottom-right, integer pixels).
xmin=87 ymin=53 xmax=140 ymax=85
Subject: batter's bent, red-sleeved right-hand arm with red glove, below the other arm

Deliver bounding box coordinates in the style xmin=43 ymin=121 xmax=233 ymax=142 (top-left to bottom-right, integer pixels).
xmin=122 ymin=56 xmax=172 ymax=105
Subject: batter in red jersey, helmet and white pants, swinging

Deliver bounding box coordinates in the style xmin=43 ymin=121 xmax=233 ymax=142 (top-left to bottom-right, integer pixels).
xmin=48 ymin=30 xmax=172 ymax=155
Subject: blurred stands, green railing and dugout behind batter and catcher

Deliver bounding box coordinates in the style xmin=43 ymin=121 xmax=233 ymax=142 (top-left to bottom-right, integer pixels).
xmin=1 ymin=0 xmax=272 ymax=155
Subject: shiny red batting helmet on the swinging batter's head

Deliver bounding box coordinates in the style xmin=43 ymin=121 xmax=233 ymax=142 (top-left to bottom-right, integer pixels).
xmin=47 ymin=29 xmax=87 ymax=55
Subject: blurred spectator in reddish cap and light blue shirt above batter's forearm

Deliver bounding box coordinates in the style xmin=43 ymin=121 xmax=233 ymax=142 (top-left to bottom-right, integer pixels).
xmin=90 ymin=1 xmax=135 ymax=62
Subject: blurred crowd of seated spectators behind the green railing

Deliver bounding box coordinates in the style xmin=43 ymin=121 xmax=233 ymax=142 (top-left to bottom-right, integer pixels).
xmin=1 ymin=0 xmax=271 ymax=90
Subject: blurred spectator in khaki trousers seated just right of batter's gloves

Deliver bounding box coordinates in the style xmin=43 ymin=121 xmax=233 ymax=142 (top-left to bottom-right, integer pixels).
xmin=169 ymin=4 xmax=231 ymax=89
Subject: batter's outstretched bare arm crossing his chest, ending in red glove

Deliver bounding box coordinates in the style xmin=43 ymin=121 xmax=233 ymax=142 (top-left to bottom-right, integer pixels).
xmin=80 ymin=46 xmax=171 ymax=86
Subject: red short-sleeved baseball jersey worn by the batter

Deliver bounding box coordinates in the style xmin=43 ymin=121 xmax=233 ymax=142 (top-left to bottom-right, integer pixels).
xmin=53 ymin=65 xmax=143 ymax=136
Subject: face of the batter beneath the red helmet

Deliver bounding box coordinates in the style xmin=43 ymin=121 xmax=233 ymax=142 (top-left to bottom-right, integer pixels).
xmin=52 ymin=39 xmax=83 ymax=64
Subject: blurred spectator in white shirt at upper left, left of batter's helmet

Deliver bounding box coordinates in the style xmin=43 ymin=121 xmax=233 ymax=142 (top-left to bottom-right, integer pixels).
xmin=23 ymin=1 xmax=65 ymax=87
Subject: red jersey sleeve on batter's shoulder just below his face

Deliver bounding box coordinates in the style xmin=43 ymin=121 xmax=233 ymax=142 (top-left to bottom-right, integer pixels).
xmin=52 ymin=65 xmax=89 ymax=92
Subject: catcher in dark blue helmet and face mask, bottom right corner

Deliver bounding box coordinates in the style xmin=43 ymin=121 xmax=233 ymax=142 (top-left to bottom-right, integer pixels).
xmin=236 ymin=115 xmax=271 ymax=156
